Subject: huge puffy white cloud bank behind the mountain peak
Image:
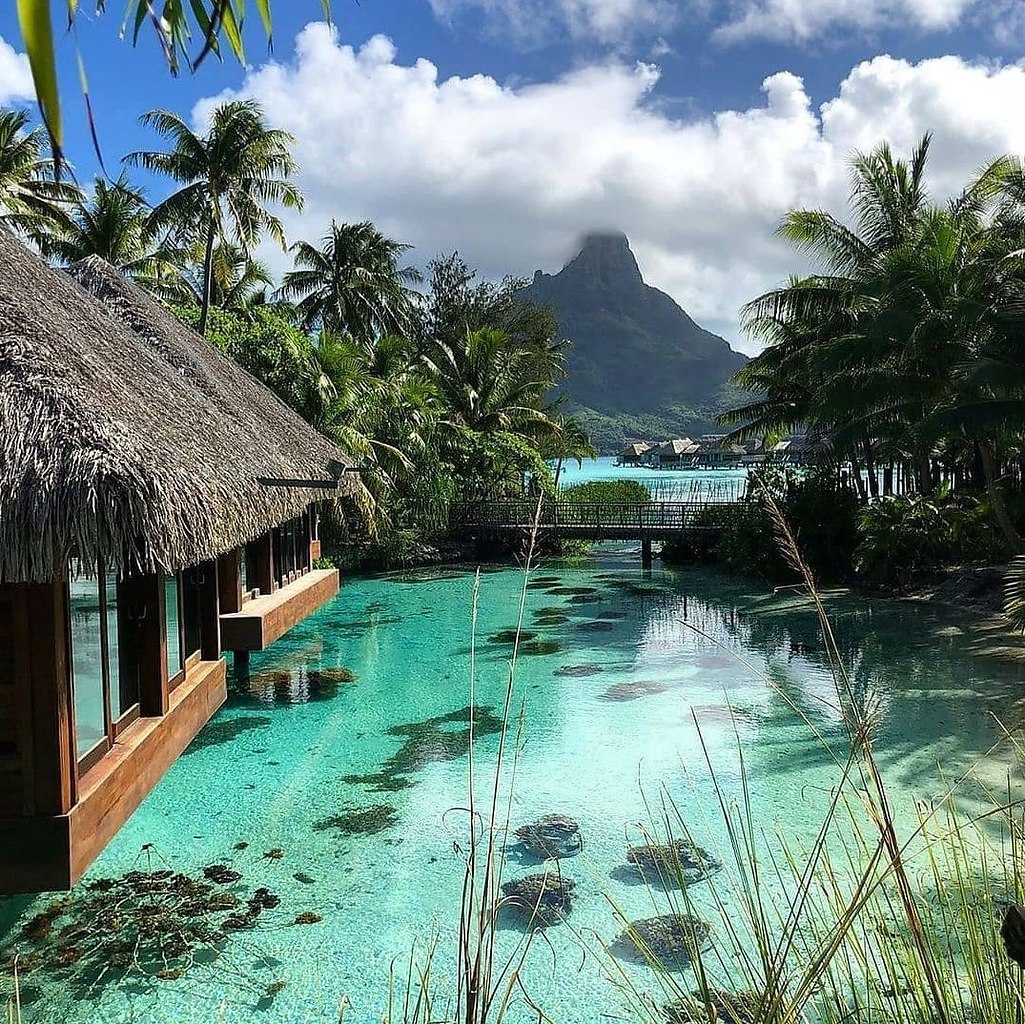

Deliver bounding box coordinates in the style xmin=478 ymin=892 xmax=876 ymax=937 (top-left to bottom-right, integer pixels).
xmin=196 ymin=25 xmax=1025 ymax=351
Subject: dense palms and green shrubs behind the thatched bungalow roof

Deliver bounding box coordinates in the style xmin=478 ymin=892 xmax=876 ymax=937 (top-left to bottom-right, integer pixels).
xmin=0 ymin=100 xmax=591 ymax=559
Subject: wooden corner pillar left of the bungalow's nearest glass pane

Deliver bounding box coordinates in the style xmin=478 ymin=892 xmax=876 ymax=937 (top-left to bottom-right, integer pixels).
xmin=22 ymin=580 xmax=78 ymax=816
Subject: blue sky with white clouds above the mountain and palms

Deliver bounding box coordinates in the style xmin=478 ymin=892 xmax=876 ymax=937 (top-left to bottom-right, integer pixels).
xmin=0 ymin=0 xmax=1025 ymax=351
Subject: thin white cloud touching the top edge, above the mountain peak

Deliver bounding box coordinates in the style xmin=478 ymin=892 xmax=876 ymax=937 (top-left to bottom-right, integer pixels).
xmin=429 ymin=0 xmax=680 ymax=44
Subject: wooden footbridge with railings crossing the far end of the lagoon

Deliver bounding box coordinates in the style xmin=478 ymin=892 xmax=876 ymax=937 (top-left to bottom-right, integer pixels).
xmin=449 ymin=500 xmax=737 ymax=565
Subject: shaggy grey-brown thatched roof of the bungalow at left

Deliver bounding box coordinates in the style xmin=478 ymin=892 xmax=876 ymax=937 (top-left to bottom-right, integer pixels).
xmin=0 ymin=231 xmax=354 ymax=582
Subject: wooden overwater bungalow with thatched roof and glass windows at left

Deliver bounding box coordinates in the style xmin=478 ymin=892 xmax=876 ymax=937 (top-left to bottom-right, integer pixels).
xmin=0 ymin=232 xmax=351 ymax=893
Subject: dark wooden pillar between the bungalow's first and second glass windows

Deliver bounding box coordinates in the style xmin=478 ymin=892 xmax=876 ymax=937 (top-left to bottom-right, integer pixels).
xmin=118 ymin=573 xmax=168 ymax=719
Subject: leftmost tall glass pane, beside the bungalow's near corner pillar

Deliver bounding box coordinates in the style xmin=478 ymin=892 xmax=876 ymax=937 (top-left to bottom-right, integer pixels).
xmin=69 ymin=574 xmax=107 ymax=757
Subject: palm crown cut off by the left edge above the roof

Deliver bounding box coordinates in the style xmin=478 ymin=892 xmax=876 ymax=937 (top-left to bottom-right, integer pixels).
xmin=0 ymin=110 xmax=80 ymax=239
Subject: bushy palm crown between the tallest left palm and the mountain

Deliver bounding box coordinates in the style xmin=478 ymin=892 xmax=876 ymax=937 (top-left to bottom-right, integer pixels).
xmin=281 ymin=220 xmax=420 ymax=343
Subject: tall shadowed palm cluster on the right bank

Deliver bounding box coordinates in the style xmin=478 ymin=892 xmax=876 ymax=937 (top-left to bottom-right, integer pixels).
xmin=723 ymin=135 xmax=1025 ymax=594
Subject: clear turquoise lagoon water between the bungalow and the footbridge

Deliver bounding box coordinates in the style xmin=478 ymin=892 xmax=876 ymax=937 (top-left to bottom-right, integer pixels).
xmin=0 ymin=549 xmax=1025 ymax=1024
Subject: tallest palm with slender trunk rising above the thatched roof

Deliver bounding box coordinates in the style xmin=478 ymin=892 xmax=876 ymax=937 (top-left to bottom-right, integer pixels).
xmin=125 ymin=99 xmax=302 ymax=333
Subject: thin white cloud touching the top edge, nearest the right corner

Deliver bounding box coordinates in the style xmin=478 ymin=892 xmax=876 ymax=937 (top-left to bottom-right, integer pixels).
xmin=714 ymin=0 xmax=984 ymax=42
